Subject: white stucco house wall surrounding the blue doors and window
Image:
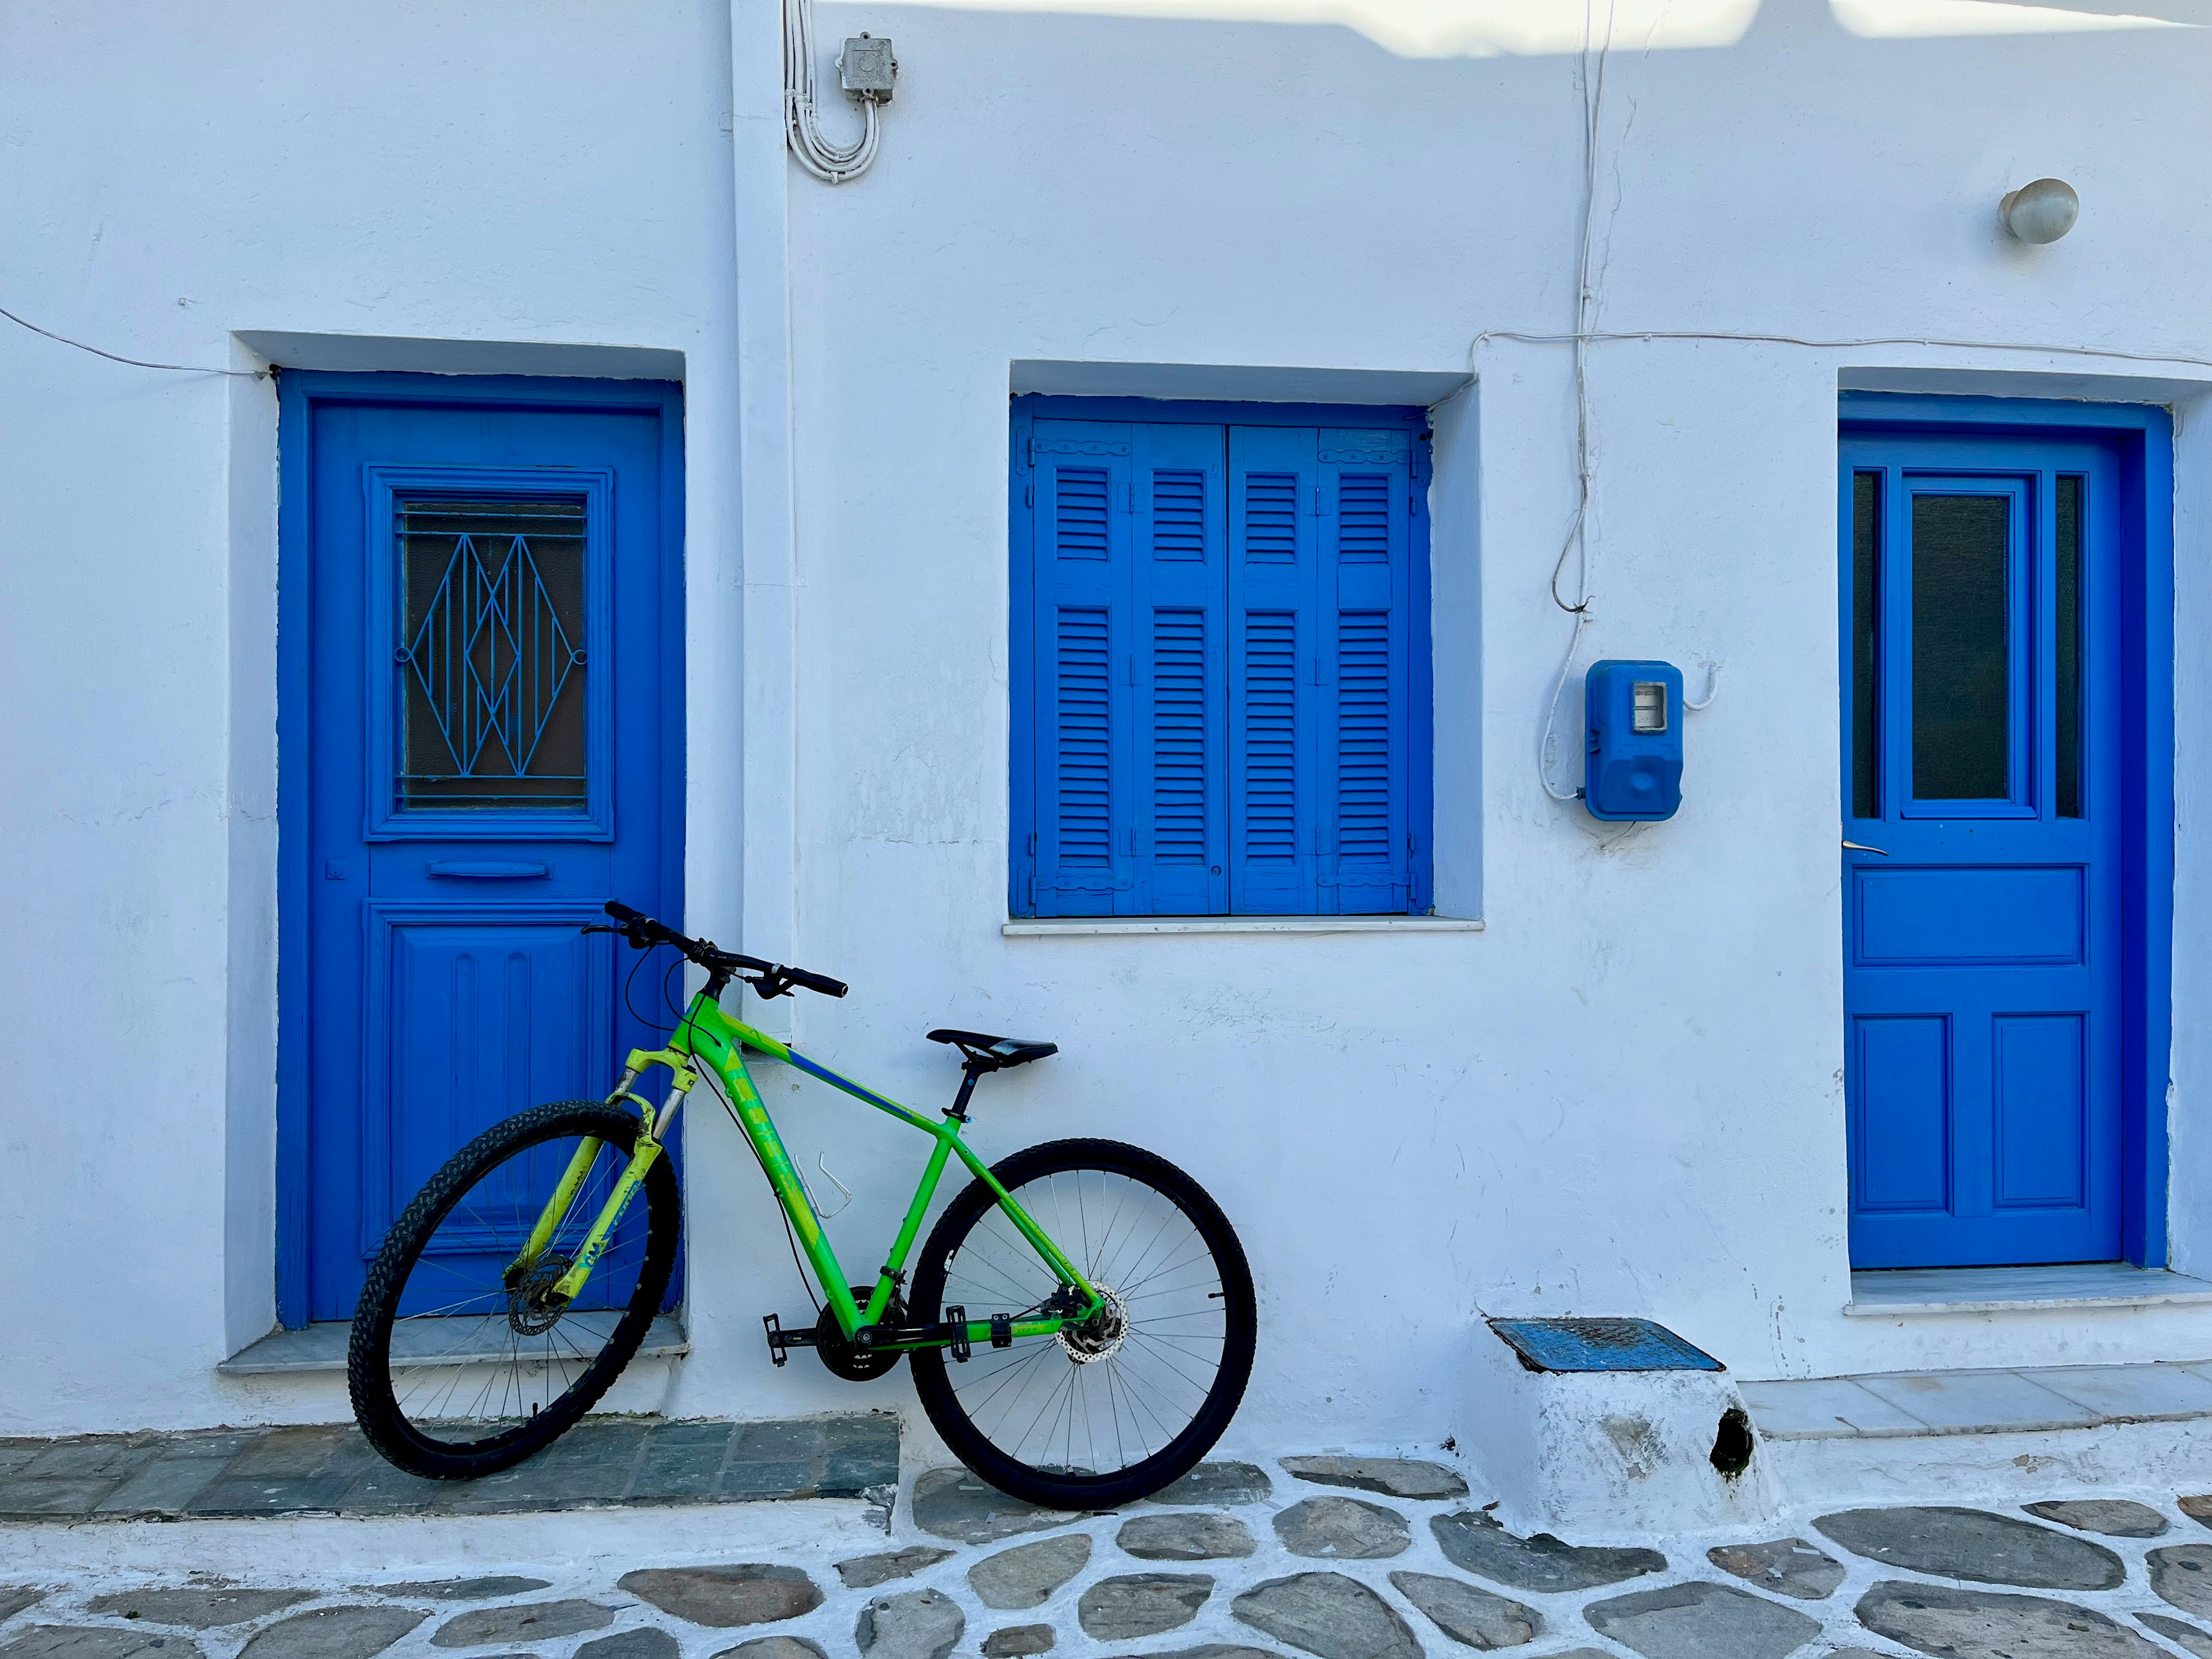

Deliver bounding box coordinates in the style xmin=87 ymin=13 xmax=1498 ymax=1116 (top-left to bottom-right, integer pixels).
xmin=0 ymin=0 xmax=2212 ymax=1445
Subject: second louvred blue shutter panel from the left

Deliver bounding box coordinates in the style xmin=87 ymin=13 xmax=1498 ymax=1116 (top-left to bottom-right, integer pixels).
xmin=1130 ymin=425 xmax=1230 ymax=916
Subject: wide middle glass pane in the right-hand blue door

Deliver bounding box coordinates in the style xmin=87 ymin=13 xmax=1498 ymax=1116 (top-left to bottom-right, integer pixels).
xmin=1911 ymin=493 xmax=2011 ymax=801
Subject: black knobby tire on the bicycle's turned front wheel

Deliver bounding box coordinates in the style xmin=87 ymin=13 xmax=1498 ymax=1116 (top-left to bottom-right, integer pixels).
xmin=345 ymin=1099 xmax=681 ymax=1480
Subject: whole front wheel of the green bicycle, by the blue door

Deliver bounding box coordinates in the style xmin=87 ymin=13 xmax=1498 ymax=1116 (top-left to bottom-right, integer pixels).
xmin=345 ymin=1101 xmax=679 ymax=1480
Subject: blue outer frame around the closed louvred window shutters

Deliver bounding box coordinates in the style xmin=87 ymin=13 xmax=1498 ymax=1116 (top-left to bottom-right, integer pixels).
xmin=1006 ymin=394 xmax=1435 ymax=922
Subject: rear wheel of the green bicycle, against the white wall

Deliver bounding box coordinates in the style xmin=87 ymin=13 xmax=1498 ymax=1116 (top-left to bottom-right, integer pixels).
xmin=909 ymin=1141 xmax=1259 ymax=1509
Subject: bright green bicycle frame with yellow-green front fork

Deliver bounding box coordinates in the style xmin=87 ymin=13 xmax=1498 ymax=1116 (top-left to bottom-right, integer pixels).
xmin=506 ymin=991 xmax=1104 ymax=1351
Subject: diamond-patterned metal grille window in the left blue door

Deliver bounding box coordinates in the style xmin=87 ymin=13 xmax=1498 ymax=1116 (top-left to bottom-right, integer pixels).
xmin=394 ymin=498 xmax=588 ymax=812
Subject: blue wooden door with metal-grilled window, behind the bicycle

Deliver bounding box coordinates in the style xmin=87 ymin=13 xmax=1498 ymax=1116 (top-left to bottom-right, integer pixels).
xmin=281 ymin=376 xmax=681 ymax=1323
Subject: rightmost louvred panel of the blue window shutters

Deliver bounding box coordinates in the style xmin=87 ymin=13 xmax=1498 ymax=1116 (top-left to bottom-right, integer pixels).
xmin=1316 ymin=427 xmax=1414 ymax=916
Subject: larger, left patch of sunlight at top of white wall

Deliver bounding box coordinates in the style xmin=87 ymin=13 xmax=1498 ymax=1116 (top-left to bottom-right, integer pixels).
xmin=854 ymin=0 xmax=1752 ymax=58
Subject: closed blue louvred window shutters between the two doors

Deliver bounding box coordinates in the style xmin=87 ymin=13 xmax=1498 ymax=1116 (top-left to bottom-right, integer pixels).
xmin=1011 ymin=398 xmax=1429 ymax=916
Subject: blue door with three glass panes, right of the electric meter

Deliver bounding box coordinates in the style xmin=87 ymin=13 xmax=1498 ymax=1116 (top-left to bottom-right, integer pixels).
xmin=1838 ymin=394 xmax=2172 ymax=1267
